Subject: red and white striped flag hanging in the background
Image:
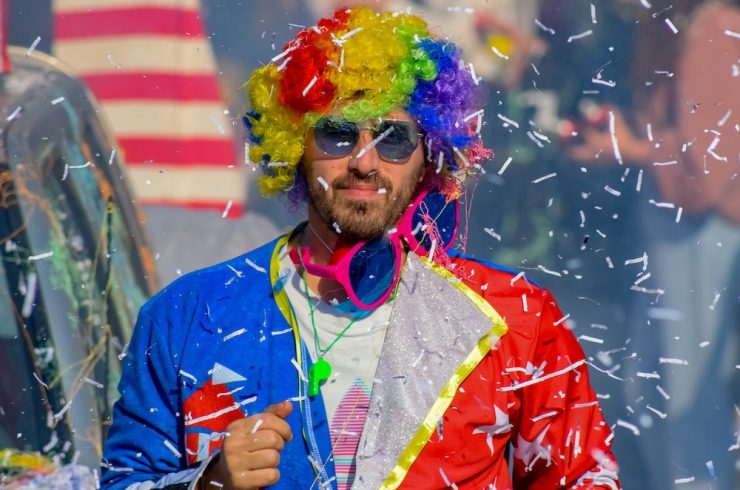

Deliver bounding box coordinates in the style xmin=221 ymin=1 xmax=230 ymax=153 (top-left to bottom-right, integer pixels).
xmin=52 ymin=0 xmax=246 ymax=217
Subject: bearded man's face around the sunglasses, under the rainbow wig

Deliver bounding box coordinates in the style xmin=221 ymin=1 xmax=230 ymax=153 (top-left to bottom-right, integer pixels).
xmin=302 ymin=111 xmax=424 ymax=241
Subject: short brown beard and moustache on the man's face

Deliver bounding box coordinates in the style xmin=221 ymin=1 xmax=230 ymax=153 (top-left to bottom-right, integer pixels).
xmin=303 ymin=162 xmax=424 ymax=241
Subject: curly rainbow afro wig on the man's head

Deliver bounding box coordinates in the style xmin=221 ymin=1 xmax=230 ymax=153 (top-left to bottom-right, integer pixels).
xmin=243 ymin=7 xmax=491 ymax=199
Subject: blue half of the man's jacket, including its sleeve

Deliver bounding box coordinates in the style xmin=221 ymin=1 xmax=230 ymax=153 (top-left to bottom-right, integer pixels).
xmin=101 ymin=237 xmax=334 ymax=489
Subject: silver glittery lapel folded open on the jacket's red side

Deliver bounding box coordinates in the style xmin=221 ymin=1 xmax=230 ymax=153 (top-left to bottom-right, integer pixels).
xmin=352 ymin=254 xmax=492 ymax=488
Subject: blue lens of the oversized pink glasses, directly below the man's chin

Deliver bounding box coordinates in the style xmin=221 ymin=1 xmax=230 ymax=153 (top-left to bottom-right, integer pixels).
xmin=349 ymin=237 xmax=398 ymax=305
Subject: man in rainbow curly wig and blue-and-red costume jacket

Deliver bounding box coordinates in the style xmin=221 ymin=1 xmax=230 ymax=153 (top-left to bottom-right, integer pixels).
xmin=102 ymin=8 xmax=619 ymax=489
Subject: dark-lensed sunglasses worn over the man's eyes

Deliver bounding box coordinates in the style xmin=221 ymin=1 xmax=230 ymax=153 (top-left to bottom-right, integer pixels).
xmin=313 ymin=116 xmax=422 ymax=162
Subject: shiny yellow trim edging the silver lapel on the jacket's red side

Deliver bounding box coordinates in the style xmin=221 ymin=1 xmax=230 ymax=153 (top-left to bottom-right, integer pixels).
xmin=380 ymin=259 xmax=509 ymax=490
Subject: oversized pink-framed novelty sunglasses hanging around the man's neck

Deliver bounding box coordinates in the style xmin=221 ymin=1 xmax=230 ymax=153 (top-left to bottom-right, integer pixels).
xmin=290 ymin=190 xmax=459 ymax=310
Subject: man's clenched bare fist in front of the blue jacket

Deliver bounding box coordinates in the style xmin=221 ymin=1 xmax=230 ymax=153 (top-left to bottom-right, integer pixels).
xmin=200 ymin=401 xmax=293 ymax=490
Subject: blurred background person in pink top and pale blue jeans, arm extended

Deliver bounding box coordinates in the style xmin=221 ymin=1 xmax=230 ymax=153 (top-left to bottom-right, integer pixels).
xmin=569 ymin=0 xmax=740 ymax=489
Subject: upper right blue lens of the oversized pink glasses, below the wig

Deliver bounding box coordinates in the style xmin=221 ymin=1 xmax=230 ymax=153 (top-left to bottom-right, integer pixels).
xmin=411 ymin=192 xmax=458 ymax=251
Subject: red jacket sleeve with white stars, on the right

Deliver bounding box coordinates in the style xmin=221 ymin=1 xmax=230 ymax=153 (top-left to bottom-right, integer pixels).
xmin=505 ymin=291 xmax=620 ymax=490
